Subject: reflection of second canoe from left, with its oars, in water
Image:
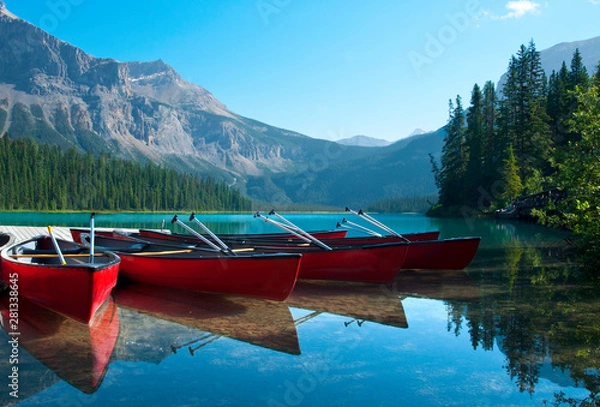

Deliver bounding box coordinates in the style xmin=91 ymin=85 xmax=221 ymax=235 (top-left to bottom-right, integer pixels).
xmin=113 ymin=282 xmax=300 ymax=355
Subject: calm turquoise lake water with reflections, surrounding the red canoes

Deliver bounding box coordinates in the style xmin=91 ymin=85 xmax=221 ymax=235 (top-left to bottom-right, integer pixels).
xmin=0 ymin=214 xmax=600 ymax=406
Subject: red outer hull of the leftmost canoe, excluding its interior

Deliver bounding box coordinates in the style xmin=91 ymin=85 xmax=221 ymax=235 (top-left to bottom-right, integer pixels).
xmin=1 ymin=237 xmax=119 ymax=324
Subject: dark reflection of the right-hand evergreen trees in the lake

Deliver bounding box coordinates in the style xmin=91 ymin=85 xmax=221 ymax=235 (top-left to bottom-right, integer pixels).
xmin=400 ymin=231 xmax=600 ymax=406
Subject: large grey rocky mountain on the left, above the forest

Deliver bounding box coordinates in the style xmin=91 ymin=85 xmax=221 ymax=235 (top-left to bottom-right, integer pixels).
xmin=0 ymin=8 xmax=370 ymax=184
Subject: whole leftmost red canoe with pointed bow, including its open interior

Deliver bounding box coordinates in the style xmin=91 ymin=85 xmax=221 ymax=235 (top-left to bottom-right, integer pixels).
xmin=2 ymin=236 xmax=120 ymax=324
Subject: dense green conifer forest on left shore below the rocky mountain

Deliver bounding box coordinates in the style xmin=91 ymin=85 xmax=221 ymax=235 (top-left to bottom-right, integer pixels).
xmin=0 ymin=135 xmax=251 ymax=211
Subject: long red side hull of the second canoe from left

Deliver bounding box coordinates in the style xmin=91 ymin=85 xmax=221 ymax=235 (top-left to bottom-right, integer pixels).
xmin=118 ymin=252 xmax=301 ymax=301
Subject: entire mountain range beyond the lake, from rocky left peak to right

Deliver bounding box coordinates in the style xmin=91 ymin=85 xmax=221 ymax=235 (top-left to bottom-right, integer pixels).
xmin=0 ymin=0 xmax=598 ymax=208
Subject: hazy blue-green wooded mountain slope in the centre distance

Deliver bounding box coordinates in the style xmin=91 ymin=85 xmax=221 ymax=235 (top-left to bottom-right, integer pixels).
xmin=264 ymin=128 xmax=445 ymax=208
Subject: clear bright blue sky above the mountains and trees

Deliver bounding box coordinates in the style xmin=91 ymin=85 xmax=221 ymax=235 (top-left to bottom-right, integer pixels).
xmin=5 ymin=0 xmax=600 ymax=140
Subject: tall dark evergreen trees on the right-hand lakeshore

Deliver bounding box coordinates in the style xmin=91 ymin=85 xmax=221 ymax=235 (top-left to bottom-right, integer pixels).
xmin=430 ymin=41 xmax=600 ymax=262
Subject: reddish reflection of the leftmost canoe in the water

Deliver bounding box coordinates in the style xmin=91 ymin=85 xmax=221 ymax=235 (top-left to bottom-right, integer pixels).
xmin=0 ymin=295 xmax=119 ymax=394
